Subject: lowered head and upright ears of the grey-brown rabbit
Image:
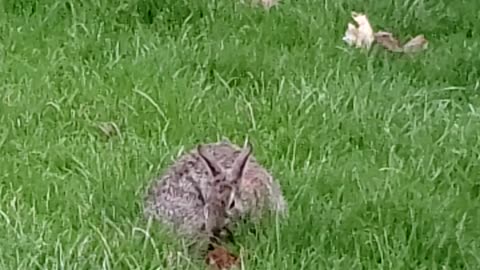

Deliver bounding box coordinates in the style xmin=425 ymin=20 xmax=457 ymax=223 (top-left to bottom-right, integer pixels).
xmin=197 ymin=144 xmax=252 ymax=239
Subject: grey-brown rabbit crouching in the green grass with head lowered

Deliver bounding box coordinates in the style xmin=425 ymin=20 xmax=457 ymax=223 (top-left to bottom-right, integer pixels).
xmin=144 ymin=140 xmax=288 ymax=242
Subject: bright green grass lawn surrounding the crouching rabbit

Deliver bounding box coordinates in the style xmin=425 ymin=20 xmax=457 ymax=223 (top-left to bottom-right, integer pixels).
xmin=0 ymin=0 xmax=480 ymax=269
